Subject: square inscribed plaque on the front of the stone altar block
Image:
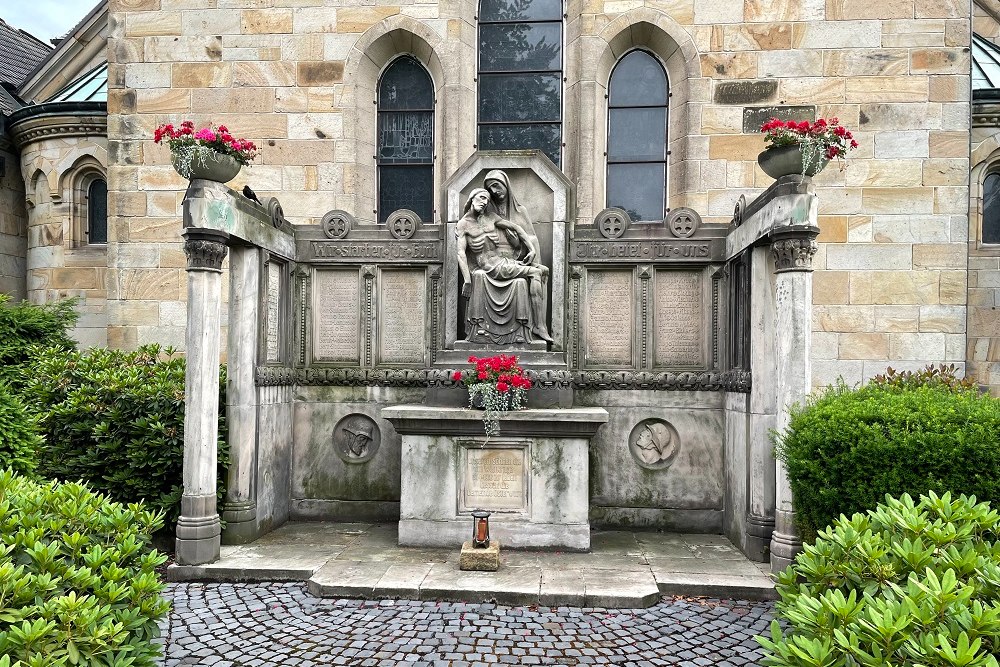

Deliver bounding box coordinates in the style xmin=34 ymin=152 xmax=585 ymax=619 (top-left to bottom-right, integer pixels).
xmin=463 ymin=447 xmax=528 ymax=511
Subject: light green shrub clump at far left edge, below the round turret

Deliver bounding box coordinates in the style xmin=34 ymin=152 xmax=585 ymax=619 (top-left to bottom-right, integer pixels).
xmin=0 ymin=294 xmax=78 ymax=385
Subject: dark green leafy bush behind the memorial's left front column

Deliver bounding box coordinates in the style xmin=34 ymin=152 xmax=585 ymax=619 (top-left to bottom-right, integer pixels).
xmin=25 ymin=345 xmax=229 ymax=524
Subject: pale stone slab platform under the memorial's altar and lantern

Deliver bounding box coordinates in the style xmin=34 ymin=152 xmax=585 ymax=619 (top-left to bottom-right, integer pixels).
xmin=167 ymin=522 xmax=776 ymax=608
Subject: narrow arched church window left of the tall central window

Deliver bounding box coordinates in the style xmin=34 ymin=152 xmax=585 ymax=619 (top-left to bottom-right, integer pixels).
xmin=376 ymin=56 xmax=434 ymax=222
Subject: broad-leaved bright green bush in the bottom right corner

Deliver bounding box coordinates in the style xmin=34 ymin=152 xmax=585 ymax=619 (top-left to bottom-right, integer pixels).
xmin=757 ymin=494 xmax=1000 ymax=667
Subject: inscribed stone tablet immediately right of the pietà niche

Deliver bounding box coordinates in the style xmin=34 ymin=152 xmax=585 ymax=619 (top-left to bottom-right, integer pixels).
xmin=583 ymin=269 xmax=634 ymax=366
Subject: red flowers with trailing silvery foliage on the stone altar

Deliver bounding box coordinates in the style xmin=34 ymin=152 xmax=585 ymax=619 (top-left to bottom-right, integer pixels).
xmin=452 ymin=354 xmax=532 ymax=439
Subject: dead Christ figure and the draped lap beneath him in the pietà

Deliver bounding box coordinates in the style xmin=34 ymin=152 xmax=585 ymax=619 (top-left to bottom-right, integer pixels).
xmin=456 ymin=188 xmax=550 ymax=345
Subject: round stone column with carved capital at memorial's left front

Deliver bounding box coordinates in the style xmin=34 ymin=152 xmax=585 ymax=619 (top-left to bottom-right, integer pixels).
xmin=176 ymin=229 xmax=229 ymax=565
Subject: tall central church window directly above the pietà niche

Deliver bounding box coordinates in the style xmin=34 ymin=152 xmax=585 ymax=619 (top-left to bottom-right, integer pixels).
xmin=478 ymin=0 xmax=563 ymax=165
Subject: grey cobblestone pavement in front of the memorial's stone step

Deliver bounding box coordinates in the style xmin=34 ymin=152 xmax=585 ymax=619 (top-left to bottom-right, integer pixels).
xmin=163 ymin=583 xmax=773 ymax=667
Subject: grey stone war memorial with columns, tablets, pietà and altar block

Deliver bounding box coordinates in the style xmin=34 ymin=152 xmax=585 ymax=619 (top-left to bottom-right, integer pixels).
xmin=177 ymin=140 xmax=819 ymax=567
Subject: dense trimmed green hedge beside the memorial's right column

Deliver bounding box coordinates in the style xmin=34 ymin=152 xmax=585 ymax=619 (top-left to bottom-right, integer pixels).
xmin=776 ymin=379 xmax=1000 ymax=540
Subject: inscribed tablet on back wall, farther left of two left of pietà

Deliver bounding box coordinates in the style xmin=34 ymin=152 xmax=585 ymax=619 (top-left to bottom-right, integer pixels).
xmin=313 ymin=269 xmax=361 ymax=364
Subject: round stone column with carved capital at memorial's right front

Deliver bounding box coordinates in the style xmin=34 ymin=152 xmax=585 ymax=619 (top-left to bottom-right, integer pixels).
xmin=771 ymin=230 xmax=819 ymax=572
